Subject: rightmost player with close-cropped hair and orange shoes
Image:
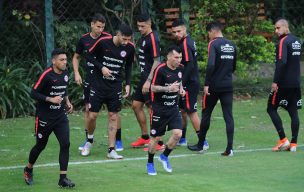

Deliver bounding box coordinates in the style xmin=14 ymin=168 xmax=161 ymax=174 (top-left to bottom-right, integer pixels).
xmin=267 ymin=19 xmax=302 ymax=152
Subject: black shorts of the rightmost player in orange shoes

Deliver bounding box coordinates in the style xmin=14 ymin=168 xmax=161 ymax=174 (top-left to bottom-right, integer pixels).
xmin=268 ymin=88 xmax=302 ymax=110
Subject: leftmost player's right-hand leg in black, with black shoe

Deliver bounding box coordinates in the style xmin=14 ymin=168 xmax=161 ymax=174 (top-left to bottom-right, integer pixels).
xmin=54 ymin=117 xmax=75 ymax=188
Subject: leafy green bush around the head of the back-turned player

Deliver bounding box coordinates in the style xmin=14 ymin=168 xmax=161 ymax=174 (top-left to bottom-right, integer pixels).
xmin=191 ymin=0 xmax=275 ymax=78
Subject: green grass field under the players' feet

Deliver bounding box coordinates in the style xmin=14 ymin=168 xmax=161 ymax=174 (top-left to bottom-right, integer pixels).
xmin=0 ymin=99 xmax=304 ymax=192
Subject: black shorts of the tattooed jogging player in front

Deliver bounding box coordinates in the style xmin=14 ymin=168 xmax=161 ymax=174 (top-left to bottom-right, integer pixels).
xmin=150 ymin=109 xmax=182 ymax=137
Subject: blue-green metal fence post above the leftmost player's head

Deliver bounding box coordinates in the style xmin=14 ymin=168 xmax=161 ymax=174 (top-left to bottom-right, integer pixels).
xmin=44 ymin=0 xmax=54 ymax=67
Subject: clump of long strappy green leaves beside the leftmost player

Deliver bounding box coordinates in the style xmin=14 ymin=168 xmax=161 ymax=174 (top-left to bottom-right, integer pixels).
xmin=0 ymin=59 xmax=41 ymax=118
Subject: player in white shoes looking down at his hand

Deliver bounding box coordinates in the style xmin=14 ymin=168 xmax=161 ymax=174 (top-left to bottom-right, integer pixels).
xmin=81 ymin=24 xmax=135 ymax=159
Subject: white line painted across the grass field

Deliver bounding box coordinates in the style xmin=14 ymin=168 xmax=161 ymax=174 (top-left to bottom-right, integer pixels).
xmin=0 ymin=145 xmax=304 ymax=171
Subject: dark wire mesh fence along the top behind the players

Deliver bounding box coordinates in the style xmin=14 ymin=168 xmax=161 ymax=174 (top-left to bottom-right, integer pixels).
xmin=0 ymin=0 xmax=304 ymax=65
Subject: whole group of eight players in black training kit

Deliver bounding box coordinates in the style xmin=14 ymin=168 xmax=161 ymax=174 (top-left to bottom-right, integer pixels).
xmin=24 ymin=14 xmax=302 ymax=188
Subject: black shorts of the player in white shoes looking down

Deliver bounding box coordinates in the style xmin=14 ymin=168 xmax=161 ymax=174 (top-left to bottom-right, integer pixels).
xmin=89 ymin=87 xmax=122 ymax=113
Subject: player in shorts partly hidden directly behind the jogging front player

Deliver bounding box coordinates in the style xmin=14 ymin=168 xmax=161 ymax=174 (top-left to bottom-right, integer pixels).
xmin=172 ymin=19 xmax=209 ymax=150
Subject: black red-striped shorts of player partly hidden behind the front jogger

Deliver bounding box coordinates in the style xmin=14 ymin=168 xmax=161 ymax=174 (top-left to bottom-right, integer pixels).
xmin=179 ymin=84 xmax=200 ymax=113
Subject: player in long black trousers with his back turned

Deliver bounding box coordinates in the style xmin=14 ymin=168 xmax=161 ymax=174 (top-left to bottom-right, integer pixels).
xmin=188 ymin=22 xmax=236 ymax=156
